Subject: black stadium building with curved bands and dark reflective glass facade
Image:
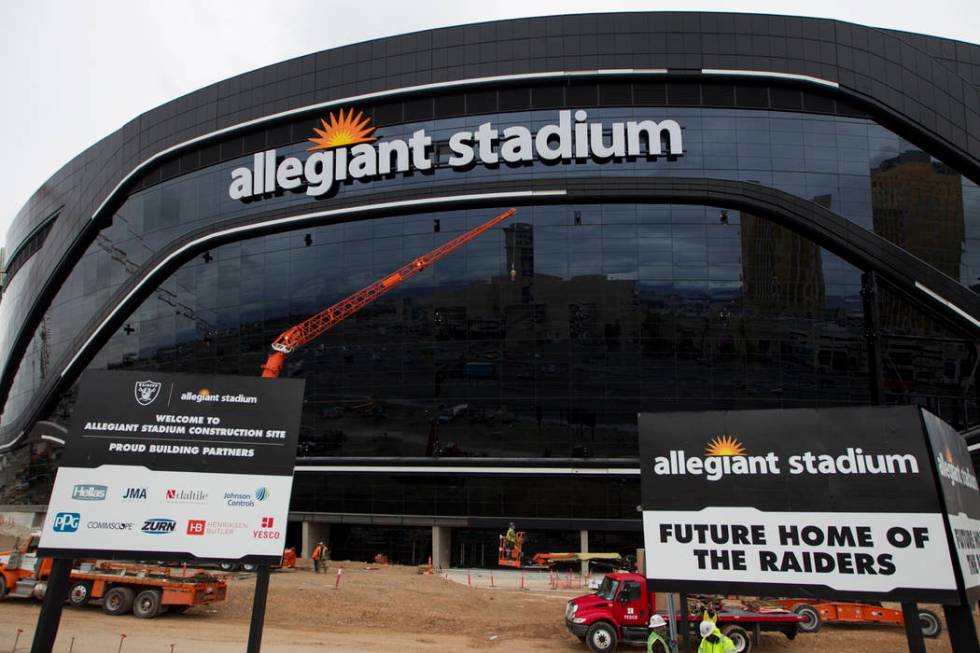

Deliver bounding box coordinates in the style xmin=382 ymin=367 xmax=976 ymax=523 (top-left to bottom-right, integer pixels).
xmin=0 ymin=13 xmax=980 ymax=565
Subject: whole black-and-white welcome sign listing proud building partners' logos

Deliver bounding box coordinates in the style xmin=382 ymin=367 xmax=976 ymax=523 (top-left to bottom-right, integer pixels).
xmin=38 ymin=371 xmax=304 ymax=564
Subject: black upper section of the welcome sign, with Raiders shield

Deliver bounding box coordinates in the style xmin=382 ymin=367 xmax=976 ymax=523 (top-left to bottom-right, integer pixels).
xmin=61 ymin=371 xmax=305 ymax=475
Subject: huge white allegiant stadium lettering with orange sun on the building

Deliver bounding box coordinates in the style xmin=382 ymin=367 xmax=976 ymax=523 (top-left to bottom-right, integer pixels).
xmin=228 ymin=109 xmax=684 ymax=200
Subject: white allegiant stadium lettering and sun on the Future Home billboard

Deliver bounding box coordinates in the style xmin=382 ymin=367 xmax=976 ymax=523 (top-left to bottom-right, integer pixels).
xmin=653 ymin=435 xmax=919 ymax=481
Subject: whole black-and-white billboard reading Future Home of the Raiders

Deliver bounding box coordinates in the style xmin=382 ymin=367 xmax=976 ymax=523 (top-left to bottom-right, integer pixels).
xmin=639 ymin=406 xmax=980 ymax=604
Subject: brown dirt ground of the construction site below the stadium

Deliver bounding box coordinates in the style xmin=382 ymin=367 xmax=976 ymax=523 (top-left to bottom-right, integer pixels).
xmin=0 ymin=562 xmax=976 ymax=653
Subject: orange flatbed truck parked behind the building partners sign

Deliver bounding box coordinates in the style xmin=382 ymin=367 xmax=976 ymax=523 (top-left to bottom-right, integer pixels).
xmin=0 ymin=533 xmax=227 ymax=619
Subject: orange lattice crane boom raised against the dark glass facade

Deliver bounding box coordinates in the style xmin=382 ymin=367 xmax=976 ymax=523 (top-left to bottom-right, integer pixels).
xmin=262 ymin=209 xmax=517 ymax=379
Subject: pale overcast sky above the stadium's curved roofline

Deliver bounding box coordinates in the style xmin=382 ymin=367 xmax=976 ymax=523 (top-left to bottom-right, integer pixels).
xmin=0 ymin=0 xmax=980 ymax=251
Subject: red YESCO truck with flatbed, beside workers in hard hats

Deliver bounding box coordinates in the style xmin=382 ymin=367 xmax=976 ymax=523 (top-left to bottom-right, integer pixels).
xmin=565 ymin=572 xmax=801 ymax=653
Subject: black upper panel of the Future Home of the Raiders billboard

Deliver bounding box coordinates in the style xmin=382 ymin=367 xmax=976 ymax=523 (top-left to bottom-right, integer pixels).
xmin=639 ymin=406 xmax=940 ymax=513
